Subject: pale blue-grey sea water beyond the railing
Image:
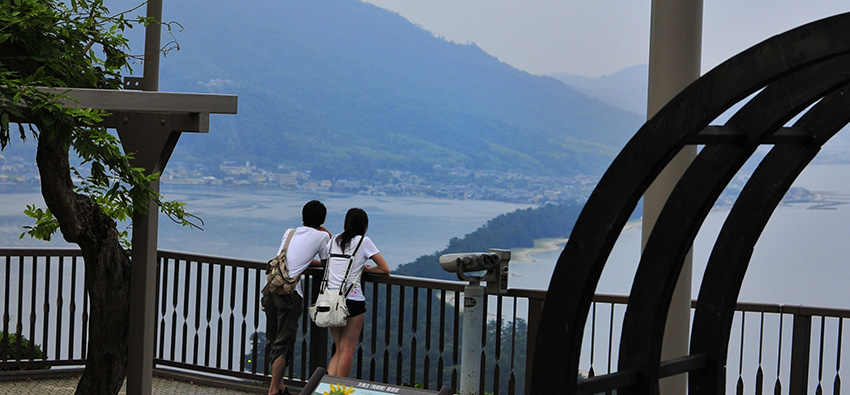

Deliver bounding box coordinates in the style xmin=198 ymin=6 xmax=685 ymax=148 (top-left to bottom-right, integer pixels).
xmin=0 ymin=164 xmax=850 ymax=308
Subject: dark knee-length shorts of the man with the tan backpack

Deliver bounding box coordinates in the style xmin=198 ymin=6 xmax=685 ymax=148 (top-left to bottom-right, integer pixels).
xmin=262 ymin=292 xmax=303 ymax=366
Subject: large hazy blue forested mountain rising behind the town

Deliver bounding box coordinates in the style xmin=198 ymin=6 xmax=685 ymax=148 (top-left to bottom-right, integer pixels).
xmin=138 ymin=0 xmax=643 ymax=178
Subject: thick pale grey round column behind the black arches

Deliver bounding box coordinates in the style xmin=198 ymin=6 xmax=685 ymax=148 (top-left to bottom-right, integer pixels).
xmin=641 ymin=0 xmax=703 ymax=395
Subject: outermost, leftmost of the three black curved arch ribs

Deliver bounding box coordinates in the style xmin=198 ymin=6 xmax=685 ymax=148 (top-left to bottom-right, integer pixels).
xmin=531 ymin=14 xmax=850 ymax=394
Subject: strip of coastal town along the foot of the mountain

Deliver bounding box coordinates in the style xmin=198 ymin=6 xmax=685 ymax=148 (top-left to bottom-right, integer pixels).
xmin=0 ymin=153 xmax=598 ymax=205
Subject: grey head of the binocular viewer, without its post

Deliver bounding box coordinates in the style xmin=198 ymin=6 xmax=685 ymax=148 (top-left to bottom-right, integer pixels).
xmin=440 ymin=248 xmax=511 ymax=293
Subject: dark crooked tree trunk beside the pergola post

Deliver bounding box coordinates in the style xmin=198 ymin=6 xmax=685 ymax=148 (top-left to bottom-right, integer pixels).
xmin=36 ymin=125 xmax=130 ymax=394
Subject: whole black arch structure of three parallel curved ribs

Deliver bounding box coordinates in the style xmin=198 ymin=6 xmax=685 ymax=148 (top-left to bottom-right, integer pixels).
xmin=531 ymin=13 xmax=850 ymax=394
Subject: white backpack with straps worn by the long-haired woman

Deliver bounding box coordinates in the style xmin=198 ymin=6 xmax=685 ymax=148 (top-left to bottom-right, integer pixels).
xmin=308 ymin=236 xmax=363 ymax=328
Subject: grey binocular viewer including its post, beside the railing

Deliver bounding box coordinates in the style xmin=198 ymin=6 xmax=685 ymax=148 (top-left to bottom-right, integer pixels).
xmin=440 ymin=248 xmax=511 ymax=395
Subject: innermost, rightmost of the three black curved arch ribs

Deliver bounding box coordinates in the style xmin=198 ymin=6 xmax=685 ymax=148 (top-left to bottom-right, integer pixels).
xmin=688 ymin=85 xmax=850 ymax=394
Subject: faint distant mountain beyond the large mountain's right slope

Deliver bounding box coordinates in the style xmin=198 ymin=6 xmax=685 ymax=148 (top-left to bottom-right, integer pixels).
xmin=550 ymin=64 xmax=649 ymax=117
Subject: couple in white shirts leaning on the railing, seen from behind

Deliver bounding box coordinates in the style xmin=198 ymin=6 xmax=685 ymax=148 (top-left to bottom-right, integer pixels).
xmin=261 ymin=200 xmax=390 ymax=395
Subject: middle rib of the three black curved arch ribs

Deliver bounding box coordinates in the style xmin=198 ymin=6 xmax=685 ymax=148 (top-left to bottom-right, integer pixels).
xmin=618 ymin=55 xmax=850 ymax=394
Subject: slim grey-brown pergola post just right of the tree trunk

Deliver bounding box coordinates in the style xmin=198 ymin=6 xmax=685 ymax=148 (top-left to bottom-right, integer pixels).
xmin=126 ymin=0 xmax=162 ymax=395
